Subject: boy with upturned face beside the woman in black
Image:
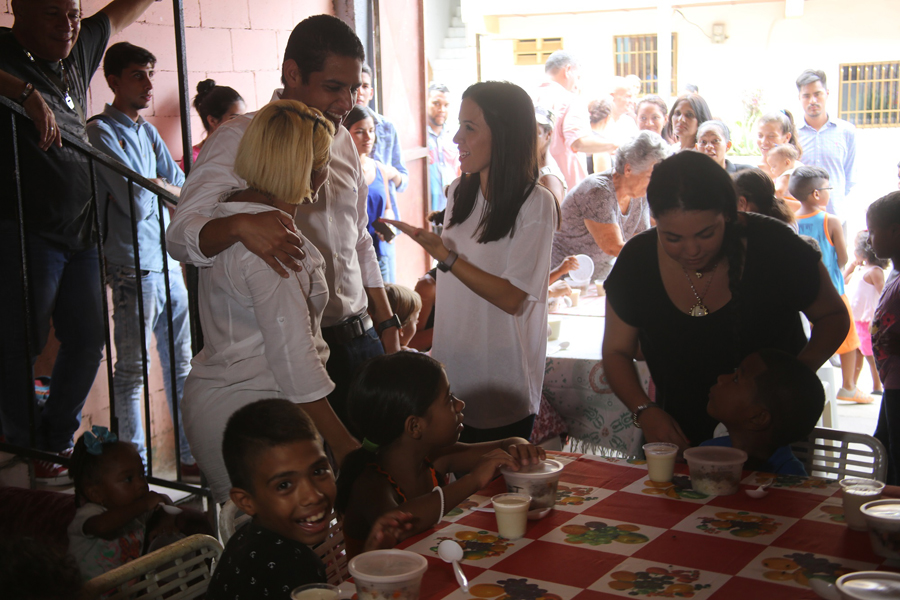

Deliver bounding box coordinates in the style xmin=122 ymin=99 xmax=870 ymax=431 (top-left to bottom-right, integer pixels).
xmin=700 ymin=350 xmax=825 ymax=475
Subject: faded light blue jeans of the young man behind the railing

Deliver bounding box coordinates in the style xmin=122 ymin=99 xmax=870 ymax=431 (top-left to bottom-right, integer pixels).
xmin=106 ymin=265 xmax=194 ymax=464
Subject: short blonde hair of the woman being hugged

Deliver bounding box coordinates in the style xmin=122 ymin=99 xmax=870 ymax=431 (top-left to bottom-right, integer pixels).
xmin=234 ymin=100 xmax=334 ymax=204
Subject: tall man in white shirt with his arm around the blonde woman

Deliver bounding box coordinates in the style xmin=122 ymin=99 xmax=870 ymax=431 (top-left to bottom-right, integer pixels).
xmin=166 ymin=15 xmax=400 ymax=424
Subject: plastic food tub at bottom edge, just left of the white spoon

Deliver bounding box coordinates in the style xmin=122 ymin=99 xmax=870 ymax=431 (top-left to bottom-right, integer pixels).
xmin=347 ymin=550 xmax=428 ymax=600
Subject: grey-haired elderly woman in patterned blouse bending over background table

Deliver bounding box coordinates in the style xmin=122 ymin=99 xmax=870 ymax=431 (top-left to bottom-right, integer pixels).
xmin=551 ymin=131 xmax=668 ymax=281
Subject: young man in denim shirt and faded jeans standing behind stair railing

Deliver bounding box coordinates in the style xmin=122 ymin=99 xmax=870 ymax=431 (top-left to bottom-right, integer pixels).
xmin=87 ymin=42 xmax=199 ymax=475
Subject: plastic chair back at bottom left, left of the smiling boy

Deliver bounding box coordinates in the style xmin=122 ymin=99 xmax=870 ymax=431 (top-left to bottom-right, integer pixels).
xmin=80 ymin=534 xmax=222 ymax=600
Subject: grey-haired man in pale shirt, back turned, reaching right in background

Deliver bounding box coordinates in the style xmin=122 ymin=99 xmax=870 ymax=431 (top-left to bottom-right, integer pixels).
xmin=533 ymin=50 xmax=617 ymax=190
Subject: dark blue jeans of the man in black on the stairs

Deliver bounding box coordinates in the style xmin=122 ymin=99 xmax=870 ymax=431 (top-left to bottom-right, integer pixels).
xmin=0 ymin=221 xmax=105 ymax=452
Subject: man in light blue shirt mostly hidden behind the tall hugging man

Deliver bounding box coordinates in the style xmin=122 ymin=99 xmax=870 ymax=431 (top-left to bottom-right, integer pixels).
xmin=356 ymin=63 xmax=409 ymax=283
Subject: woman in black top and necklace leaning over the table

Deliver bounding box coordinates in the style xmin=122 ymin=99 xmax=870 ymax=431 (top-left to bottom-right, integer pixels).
xmin=603 ymin=152 xmax=850 ymax=449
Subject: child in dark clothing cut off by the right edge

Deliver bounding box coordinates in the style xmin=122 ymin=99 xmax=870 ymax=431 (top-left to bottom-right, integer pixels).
xmin=866 ymin=191 xmax=900 ymax=485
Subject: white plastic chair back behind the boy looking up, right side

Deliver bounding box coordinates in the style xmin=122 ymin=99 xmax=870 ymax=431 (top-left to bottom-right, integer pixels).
xmin=791 ymin=427 xmax=887 ymax=481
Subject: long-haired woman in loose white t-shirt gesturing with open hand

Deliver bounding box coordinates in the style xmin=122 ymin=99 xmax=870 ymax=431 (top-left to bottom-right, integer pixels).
xmin=390 ymin=81 xmax=558 ymax=442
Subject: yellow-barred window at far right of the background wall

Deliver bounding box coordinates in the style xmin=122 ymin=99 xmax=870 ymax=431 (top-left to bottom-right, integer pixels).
xmin=838 ymin=61 xmax=900 ymax=127
